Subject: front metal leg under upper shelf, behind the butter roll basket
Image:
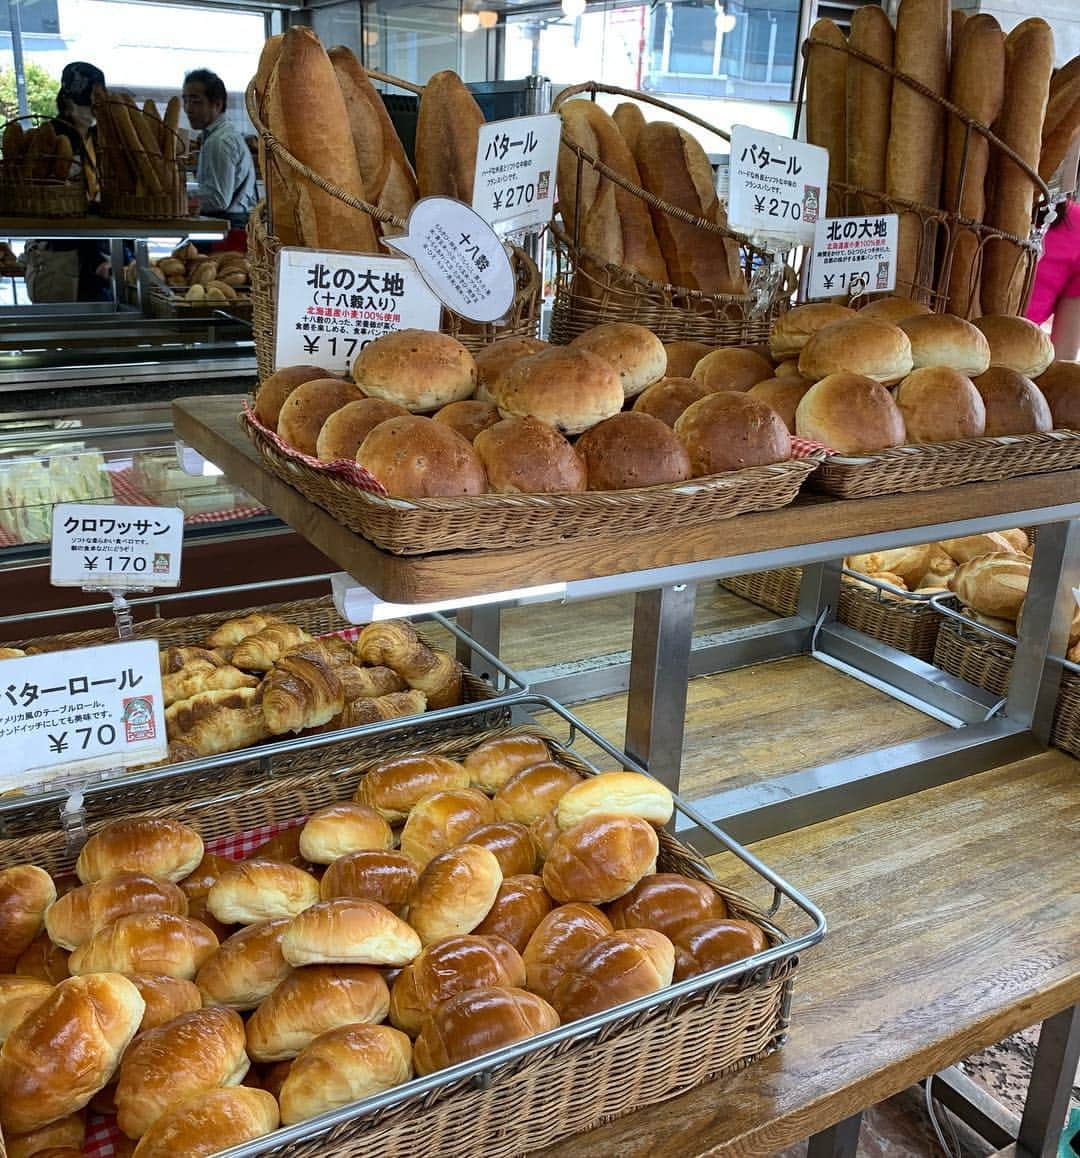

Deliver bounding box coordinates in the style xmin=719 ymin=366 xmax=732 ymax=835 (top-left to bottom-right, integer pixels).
xmin=626 ymin=584 xmax=696 ymax=792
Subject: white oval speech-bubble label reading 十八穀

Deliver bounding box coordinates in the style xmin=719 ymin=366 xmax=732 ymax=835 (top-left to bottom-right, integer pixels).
xmin=385 ymin=197 xmax=514 ymax=322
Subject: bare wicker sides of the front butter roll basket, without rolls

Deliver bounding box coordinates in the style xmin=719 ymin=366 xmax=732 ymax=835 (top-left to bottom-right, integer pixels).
xmin=0 ymin=728 xmax=798 ymax=1158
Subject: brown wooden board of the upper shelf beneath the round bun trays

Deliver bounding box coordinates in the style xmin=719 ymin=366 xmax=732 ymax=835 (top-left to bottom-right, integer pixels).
xmin=172 ymin=395 xmax=1080 ymax=603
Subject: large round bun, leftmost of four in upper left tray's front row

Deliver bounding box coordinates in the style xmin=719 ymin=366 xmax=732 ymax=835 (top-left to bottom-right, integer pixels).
xmin=357 ymin=415 xmax=487 ymax=499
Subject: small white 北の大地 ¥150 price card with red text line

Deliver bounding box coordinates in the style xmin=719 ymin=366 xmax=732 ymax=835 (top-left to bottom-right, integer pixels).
xmin=807 ymin=213 xmax=899 ymax=299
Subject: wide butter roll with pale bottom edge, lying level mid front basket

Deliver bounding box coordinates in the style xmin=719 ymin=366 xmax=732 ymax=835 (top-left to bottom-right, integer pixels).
xmin=281 ymin=896 xmax=420 ymax=969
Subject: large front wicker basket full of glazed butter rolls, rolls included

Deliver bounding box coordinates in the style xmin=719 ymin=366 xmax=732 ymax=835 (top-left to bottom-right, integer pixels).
xmin=0 ymin=728 xmax=811 ymax=1158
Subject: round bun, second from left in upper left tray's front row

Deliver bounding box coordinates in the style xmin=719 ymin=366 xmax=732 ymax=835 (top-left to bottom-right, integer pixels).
xmin=472 ymin=411 xmax=588 ymax=494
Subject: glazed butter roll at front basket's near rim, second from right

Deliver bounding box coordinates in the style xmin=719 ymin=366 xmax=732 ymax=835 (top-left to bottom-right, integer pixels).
xmin=551 ymin=929 xmax=675 ymax=1023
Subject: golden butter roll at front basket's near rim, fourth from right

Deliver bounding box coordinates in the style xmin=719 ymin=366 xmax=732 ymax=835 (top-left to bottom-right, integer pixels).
xmin=278 ymin=1025 xmax=412 ymax=1126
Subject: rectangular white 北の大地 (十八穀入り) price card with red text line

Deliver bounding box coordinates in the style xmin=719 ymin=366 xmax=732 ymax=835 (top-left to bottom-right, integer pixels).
xmin=274 ymin=247 xmax=441 ymax=374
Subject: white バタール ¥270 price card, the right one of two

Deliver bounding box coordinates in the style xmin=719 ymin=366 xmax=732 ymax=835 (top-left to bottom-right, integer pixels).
xmin=727 ymin=125 xmax=829 ymax=245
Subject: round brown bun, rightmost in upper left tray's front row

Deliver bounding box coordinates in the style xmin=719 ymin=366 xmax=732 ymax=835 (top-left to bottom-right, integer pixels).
xmin=675 ymin=391 xmax=792 ymax=478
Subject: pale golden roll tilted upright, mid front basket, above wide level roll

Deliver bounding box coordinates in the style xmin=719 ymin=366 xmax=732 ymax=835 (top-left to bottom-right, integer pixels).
xmin=409 ymin=844 xmax=502 ymax=945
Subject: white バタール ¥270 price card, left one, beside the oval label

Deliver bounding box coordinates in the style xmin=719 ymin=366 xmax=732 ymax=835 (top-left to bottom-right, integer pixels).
xmin=472 ymin=113 xmax=563 ymax=233
